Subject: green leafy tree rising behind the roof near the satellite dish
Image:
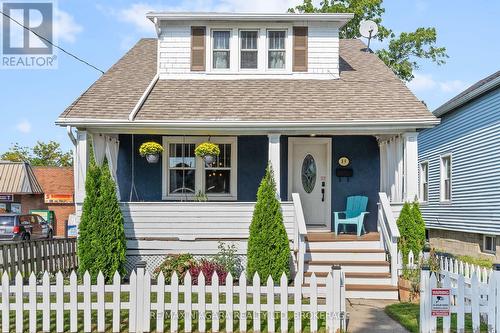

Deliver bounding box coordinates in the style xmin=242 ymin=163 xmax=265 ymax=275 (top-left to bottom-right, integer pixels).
xmin=289 ymin=0 xmax=448 ymax=81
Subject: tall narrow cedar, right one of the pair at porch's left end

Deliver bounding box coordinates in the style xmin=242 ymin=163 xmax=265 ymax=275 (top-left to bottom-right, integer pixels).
xmin=95 ymin=165 xmax=126 ymax=281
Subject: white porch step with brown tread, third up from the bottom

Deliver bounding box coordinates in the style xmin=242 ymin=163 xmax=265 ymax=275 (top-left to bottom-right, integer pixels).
xmin=304 ymin=260 xmax=390 ymax=273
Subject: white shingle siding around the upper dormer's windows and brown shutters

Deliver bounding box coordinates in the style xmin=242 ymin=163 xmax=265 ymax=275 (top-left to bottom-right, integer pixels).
xmin=158 ymin=22 xmax=339 ymax=79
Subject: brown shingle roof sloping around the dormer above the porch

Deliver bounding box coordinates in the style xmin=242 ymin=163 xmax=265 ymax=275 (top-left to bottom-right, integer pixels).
xmin=58 ymin=39 xmax=436 ymax=127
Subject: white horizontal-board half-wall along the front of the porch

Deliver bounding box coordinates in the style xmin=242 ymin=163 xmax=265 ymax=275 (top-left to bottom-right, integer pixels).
xmin=121 ymin=202 xmax=295 ymax=255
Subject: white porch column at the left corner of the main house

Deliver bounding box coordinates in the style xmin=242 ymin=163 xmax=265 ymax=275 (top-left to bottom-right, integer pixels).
xmin=73 ymin=131 xmax=89 ymax=204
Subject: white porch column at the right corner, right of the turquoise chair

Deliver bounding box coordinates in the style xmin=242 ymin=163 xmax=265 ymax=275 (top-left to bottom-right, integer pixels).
xmin=403 ymin=132 xmax=418 ymax=202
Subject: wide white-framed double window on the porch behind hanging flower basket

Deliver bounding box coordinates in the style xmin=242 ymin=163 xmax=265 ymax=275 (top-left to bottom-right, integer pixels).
xmin=163 ymin=136 xmax=237 ymax=200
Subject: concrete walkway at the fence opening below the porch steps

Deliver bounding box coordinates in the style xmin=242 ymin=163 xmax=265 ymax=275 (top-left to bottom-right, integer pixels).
xmin=347 ymin=299 xmax=408 ymax=333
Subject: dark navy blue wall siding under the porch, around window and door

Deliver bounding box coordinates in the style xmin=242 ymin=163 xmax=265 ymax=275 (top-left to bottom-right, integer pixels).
xmin=118 ymin=135 xmax=380 ymax=231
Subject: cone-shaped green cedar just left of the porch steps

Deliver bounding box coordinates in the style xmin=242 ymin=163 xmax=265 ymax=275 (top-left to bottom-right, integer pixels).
xmin=247 ymin=165 xmax=290 ymax=283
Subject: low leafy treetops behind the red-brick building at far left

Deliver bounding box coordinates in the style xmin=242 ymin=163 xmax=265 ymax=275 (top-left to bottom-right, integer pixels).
xmin=0 ymin=141 xmax=73 ymax=167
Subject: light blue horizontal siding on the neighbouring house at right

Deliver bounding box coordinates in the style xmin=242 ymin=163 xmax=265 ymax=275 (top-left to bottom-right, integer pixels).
xmin=418 ymin=89 xmax=500 ymax=234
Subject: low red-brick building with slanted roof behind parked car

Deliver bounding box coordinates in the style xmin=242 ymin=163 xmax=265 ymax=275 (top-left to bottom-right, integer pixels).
xmin=0 ymin=161 xmax=75 ymax=237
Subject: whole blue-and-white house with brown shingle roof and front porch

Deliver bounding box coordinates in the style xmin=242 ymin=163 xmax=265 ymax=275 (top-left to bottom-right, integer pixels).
xmin=57 ymin=12 xmax=439 ymax=299
